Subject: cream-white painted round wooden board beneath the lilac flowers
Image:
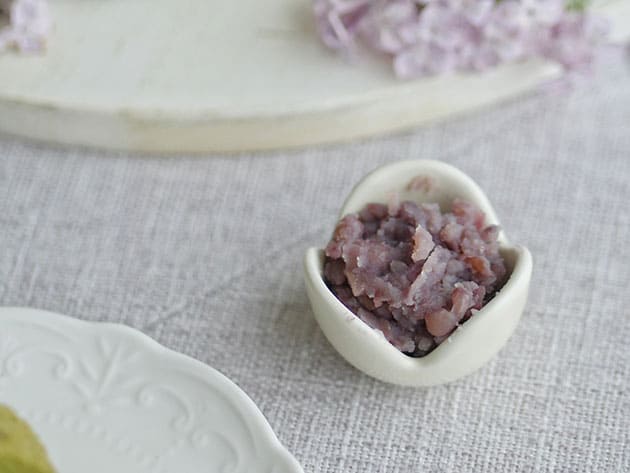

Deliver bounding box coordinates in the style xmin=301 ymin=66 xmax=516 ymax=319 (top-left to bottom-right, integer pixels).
xmin=0 ymin=0 xmax=630 ymax=152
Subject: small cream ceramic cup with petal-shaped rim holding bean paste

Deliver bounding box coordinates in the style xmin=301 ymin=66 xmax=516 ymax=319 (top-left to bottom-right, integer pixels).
xmin=304 ymin=160 xmax=532 ymax=386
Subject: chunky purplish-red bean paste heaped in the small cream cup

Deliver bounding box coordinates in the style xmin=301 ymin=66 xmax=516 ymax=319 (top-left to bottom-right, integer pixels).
xmin=324 ymin=199 xmax=506 ymax=357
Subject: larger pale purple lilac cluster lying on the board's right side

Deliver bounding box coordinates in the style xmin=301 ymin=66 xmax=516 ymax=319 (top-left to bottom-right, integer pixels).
xmin=314 ymin=0 xmax=607 ymax=78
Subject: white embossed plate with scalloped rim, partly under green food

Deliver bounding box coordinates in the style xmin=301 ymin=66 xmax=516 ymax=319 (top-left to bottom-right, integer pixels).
xmin=0 ymin=308 xmax=302 ymax=473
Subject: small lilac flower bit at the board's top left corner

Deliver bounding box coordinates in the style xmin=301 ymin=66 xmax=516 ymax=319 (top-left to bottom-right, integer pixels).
xmin=0 ymin=0 xmax=51 ymax=53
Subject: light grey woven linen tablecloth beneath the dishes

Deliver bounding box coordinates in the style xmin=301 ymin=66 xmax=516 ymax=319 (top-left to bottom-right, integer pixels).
xmin=0 ymin=60 xmax=630 ymax=473
